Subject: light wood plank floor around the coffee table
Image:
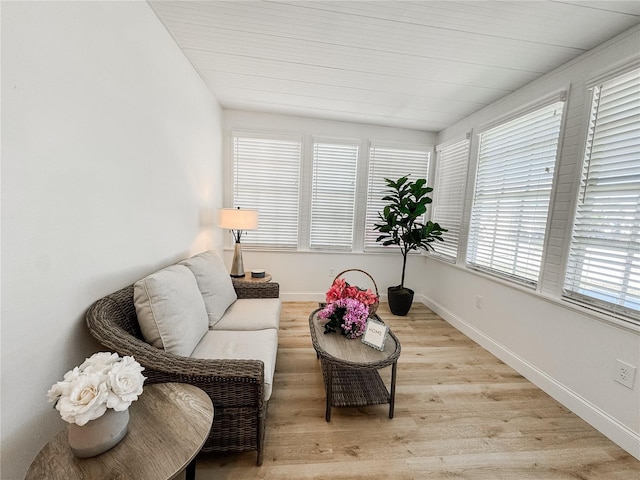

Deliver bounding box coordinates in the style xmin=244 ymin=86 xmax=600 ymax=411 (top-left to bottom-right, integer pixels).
xmin=188 ymin=302 xmax=640 ymax=480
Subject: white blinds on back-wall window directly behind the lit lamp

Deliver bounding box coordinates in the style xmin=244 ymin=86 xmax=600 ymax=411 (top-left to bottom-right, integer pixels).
xmin=233 ymin=134 xmax=302 ymax=248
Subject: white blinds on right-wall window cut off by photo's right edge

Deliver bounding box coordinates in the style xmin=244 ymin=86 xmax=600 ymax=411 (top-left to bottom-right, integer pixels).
xmin=564 ymin=69 xmax=640 ymax=319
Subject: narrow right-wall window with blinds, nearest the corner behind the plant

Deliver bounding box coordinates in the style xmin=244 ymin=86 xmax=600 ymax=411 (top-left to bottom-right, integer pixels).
xmin=431 ymin=135 xmax=469 ymax=262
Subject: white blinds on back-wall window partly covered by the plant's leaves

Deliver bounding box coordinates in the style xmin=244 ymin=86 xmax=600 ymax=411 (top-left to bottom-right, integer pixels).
xmin=364 ymin=144 xmax=431 ymax=251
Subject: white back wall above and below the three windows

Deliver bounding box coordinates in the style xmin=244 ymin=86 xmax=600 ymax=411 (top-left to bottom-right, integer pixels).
xmin=223 ymin=110 xmax=436 ymax=301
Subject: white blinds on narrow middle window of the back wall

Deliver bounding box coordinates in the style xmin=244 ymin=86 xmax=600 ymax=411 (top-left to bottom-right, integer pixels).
xmin=310 ymin=142 xmax=358 ymax=250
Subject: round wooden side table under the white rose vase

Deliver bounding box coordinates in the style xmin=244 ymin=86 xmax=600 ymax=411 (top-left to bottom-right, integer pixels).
xmin=25 ymin=383 xmax=213 ymax=480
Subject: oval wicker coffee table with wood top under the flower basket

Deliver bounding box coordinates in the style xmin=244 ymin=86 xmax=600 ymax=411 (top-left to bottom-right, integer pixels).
xmin=309 ymin=309 xmax=400 ymax=422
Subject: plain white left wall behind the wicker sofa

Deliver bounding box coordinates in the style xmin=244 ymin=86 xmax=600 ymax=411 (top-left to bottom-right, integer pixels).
xmin=1 ymin=1 xmax=222 ymax=480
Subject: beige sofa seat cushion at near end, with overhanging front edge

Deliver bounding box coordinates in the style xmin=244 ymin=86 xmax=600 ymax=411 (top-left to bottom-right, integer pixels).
xmin=191 ymin=328 xmax=278 ymax=401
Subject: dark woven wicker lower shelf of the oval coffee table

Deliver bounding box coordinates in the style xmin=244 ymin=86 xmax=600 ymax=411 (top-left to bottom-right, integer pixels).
xmin=322 ymin=361 xmax=395 ymax=422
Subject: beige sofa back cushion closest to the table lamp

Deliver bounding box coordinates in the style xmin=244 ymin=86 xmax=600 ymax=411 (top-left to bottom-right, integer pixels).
xmin=180 ymin=250 xmax=238 ymax=327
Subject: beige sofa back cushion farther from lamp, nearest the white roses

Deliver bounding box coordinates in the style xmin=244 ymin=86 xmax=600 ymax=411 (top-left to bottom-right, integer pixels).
xmin=133 ymin=265 xmax=209 ymax=357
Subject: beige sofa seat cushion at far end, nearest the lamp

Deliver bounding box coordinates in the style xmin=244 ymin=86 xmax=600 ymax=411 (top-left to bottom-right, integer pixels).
xmin=212 ymin=298 xmax=282 ymax=331
